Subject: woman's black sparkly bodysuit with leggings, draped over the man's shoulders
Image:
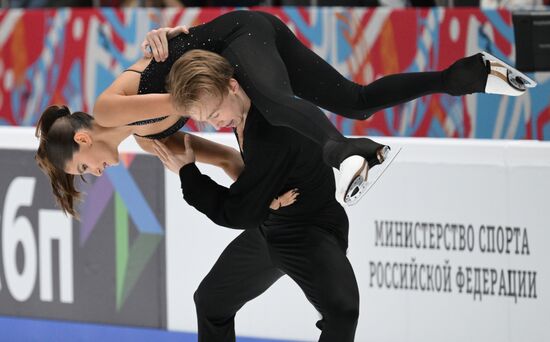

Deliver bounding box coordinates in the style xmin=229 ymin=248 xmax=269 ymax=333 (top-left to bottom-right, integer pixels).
xmin=133 ymin=11 xmax=487 ymax=167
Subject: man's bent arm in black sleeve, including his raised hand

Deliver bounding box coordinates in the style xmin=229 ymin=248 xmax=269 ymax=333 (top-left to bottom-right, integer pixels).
xmin=155 ymin=139 xmax=296 ymax=229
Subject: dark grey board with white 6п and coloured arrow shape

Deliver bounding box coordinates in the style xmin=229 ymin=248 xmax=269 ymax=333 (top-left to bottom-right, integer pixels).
xmin=0 ymin=150 xmax=166 ymax=327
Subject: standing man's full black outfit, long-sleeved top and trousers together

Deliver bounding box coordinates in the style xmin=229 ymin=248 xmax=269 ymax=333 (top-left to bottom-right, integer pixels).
xmin=180 ymin=107 xmax=359 ymax=342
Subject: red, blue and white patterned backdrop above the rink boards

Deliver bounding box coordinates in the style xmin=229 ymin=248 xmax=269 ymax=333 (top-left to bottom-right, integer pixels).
xmin=0 ymin=6 xmax=550 ymax=140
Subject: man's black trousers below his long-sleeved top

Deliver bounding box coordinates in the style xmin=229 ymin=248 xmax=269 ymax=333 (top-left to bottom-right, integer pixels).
xmin=194 ymin=224 xmax=359 ymax=342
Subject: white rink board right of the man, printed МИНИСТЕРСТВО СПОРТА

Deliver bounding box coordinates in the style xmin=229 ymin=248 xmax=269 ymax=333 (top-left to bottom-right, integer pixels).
xmin=348 ymin=139 xmax=550 ymax=342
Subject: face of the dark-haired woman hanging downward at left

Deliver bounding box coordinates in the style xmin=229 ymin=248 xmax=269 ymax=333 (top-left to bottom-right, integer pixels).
xmin=65 ymin=131 xmax=118 ymax=176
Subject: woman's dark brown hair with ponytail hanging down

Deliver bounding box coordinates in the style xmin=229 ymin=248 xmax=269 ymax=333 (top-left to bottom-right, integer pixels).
xmin=35 ymin=106 xmax=93 ymax=218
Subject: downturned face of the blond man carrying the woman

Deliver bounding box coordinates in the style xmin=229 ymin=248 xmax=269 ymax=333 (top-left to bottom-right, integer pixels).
xmin=189 ymin=79 xmax=248 ymax=129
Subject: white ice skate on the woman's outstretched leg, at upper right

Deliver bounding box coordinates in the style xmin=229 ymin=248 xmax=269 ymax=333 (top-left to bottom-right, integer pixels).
xmin=481 ymin=51 xmax=537 ymax=96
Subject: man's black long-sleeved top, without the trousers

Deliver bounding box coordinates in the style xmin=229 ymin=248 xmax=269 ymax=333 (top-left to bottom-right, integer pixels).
xmin=179 ymin=106 xmax=348 ymax=240
